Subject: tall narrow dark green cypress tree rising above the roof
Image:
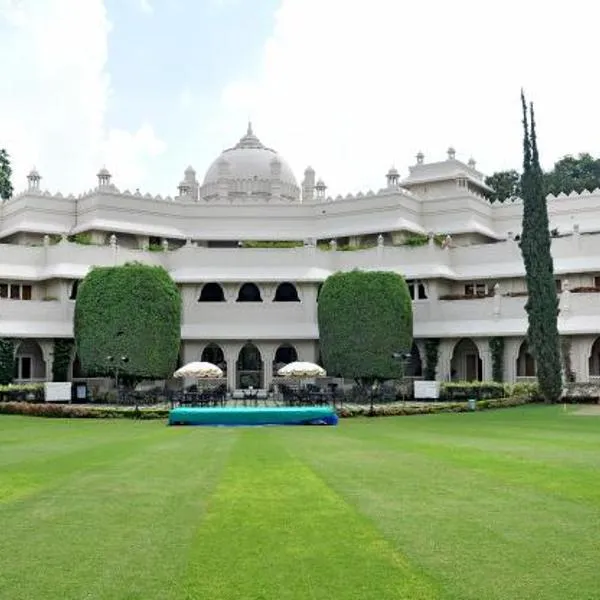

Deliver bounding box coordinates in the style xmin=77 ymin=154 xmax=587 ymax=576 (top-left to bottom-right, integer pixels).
xmin=520 ymin=92 xmax=562 ymax=402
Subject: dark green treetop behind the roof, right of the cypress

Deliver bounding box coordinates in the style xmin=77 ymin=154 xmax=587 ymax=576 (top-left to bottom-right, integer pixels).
xmin=544 ymin=153 xmax=600 ymax=195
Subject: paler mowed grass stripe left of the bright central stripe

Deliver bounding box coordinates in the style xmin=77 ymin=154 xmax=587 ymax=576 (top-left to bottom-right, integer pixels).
xmin=0 ymin=422 xmax=237 ymax=600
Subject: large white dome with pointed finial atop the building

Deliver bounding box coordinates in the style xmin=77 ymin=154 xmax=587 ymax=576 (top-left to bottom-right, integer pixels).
xmin=200 ymin=123 xmax=300 ymax=201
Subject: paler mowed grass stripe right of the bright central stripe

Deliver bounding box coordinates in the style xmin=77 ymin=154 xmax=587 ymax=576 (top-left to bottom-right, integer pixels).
xmin=286 ymin=407 xmax=600 ymax=600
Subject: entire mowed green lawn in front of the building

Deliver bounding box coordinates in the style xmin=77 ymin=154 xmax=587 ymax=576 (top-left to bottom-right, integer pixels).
xmin=0 ymin=407 xmax=600 ymax=600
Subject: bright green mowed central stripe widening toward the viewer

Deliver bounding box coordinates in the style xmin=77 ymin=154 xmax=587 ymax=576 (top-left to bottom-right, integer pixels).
xmin=181 ymin=428 xmax=438 ymax=600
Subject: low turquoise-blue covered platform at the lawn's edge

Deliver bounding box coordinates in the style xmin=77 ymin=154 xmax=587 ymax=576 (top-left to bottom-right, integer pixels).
xmin=169 ymin=406 xmax=338 ymax=427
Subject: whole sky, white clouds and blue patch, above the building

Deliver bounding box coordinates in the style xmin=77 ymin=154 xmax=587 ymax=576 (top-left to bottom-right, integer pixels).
xmin=0 ymin=0 xmax=600 ymax=196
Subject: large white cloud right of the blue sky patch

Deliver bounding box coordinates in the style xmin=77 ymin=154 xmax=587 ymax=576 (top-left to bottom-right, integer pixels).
xmin=219 ymin=0 xmax=600 ymax=194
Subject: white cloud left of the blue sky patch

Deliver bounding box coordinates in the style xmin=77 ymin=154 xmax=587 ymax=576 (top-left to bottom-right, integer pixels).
xmin=0 ymin=0 xmax=164 ymax=193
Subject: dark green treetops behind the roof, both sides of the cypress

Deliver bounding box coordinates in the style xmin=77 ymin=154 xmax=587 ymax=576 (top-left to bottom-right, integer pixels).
xmin=485 ymin=152 xmax=600 ymax=202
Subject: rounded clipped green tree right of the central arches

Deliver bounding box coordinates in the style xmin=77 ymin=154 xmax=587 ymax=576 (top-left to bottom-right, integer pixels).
xmin=318 ymin=270 xmax=413 ymax=383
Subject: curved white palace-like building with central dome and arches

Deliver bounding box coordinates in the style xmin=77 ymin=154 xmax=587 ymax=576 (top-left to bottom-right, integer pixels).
xmin=0 ymin=127 xmax=600 ymax=389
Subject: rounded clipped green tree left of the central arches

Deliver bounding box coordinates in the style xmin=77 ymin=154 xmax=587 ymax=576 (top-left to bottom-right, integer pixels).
xmin=75 ymin=263 xmax=181 ymax=380
